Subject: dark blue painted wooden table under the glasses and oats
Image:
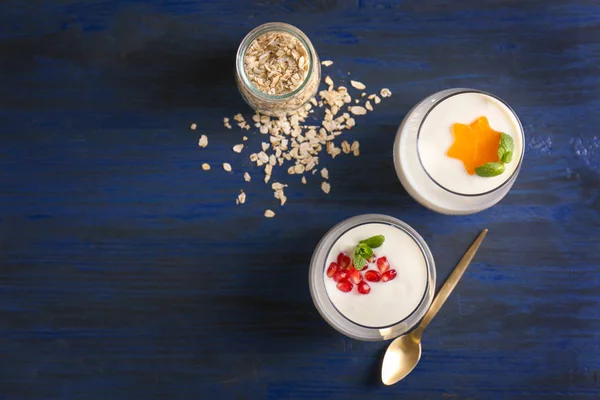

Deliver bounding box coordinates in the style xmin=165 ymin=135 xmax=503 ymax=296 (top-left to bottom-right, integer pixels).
xmin=0 ymin=0 xmax=600 ymax=400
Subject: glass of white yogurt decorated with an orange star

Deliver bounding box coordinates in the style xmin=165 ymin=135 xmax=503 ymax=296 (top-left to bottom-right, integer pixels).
xmin=394 ymin=89 xmax=525 ymax=215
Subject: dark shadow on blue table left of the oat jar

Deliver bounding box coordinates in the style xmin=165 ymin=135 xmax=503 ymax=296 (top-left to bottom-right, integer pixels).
xmin=115 ymin=38 xmax=246 ymax=111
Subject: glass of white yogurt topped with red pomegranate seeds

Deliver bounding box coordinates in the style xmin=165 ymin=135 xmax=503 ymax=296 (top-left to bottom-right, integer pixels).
xmin=309 ymin=214 xmax=436 ymax=341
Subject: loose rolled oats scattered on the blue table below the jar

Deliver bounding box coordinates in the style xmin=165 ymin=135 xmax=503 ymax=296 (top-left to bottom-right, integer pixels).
xmin=194 ymin=61 xmax=392 ymax=218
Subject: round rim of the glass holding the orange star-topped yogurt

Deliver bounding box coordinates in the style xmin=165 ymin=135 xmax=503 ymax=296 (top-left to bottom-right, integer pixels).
xmin=417 ymin=89 xmax=525 ymax=197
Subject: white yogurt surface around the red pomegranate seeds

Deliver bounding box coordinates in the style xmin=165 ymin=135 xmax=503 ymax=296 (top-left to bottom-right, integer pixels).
xmin=323 ymin=223 xmax=428 ymax=328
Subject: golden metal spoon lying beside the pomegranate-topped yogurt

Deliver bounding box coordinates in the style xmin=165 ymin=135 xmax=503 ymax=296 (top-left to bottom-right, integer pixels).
xmin=381 ymin=229 xmax=487 ymax=385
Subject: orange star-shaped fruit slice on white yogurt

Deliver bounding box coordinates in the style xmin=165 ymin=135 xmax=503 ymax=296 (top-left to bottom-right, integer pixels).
xmin=446 ymin=117 xmax=502 ymax=175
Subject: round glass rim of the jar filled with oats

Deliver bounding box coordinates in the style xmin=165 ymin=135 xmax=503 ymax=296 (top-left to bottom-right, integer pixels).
xmin=235 ymin=22 xmax=314 ymax=101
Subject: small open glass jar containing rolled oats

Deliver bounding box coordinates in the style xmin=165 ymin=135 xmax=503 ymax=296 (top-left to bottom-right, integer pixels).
xmin=236 ymin=22 xmax=321 ymax=116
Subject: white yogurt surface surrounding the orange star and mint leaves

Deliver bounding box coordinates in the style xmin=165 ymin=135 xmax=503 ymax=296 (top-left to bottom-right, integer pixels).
xmin=418 ymin=92 xmax=523 ymax=195
